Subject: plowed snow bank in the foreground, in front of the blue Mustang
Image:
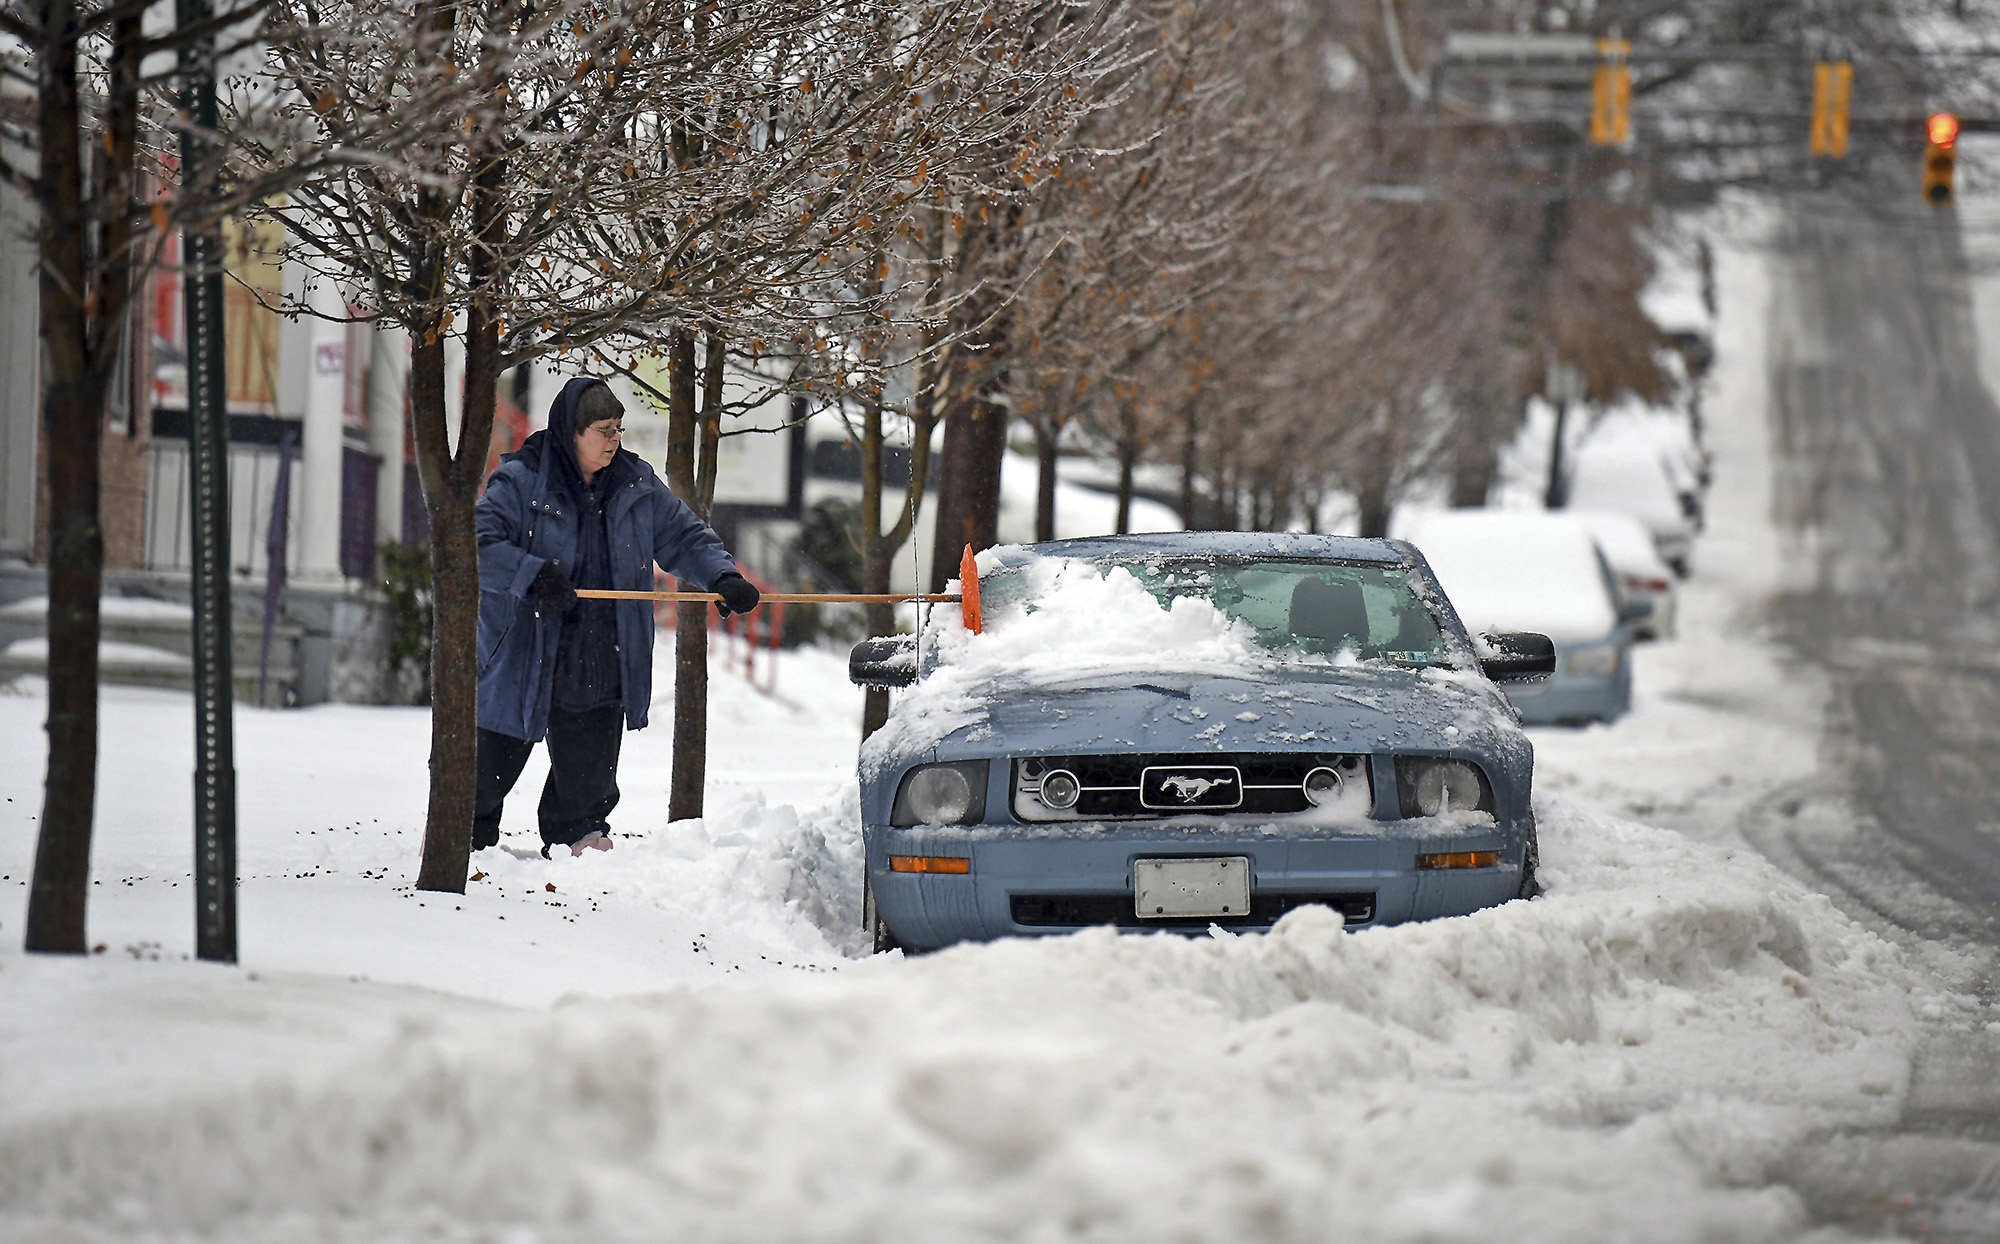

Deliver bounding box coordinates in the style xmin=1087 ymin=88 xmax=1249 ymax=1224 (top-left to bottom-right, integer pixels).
xmin=0 ymin=802 xmax=1918 ymax=1242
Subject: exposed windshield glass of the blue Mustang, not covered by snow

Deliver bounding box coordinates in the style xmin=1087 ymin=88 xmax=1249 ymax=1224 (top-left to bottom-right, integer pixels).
xmin=980 ymin=556 xmax=1452 ymax=666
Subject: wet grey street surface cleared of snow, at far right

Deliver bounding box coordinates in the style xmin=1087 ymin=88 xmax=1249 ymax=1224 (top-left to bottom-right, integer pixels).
xmin=1742 ymin=186 xmax=2000 ymax=1240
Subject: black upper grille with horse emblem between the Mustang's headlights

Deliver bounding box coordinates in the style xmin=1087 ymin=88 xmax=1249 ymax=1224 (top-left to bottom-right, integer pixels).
xmin=1012 ymin=752 xmax=1374 ymax=820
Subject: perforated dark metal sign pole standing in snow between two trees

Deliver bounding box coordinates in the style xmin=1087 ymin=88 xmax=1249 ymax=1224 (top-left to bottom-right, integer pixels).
xmin=174 ymin=0 xmax=236 ymax=964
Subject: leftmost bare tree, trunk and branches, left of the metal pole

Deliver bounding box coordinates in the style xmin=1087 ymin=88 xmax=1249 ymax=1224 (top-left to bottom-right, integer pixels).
xmin=0 ymin=0 xmax=360 ymax=954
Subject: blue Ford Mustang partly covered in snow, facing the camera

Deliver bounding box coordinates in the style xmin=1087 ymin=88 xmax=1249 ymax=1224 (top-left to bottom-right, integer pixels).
xmin=850 ymin=532 xmax=1554 ymax=950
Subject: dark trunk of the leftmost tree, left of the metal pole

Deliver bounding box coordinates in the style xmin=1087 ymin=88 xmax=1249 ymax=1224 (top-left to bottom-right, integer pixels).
xmin=26 ymin=0 xmax=104 ymax=954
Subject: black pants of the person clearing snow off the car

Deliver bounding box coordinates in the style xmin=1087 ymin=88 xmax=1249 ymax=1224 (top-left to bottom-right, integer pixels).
xmin=472 ymin=704 xmax=624 ymax=850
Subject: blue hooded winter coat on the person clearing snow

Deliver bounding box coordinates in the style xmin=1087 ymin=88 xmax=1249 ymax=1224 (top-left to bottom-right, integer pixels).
xmin=478 ymin=378 xmax=736 ymax=742
